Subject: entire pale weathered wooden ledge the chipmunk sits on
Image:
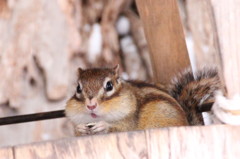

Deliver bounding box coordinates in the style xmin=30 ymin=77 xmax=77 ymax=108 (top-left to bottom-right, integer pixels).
xmin=0 ymin=125 xmax=240 ymax=159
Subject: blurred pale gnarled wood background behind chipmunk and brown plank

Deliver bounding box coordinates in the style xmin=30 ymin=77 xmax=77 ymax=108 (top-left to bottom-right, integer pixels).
xmin=0 ymin=0 xmax=217 ymax=146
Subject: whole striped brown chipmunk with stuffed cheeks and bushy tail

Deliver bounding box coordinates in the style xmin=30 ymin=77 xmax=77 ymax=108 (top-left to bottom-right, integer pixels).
xmin=65 ymin=65 xmax=219 ymax=136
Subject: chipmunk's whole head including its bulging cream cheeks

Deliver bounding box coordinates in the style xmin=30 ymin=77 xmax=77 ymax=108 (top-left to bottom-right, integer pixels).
xmin=66 ymin=65 xmax=134 ymax=122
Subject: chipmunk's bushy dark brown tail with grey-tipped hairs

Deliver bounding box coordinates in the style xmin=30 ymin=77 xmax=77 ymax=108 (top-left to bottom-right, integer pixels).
xmin=169 ymin=68 xmax=222 ymax=125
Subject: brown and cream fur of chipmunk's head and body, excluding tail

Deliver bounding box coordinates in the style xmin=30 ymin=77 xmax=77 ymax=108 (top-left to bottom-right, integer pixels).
xmin=65 ymin=66 xmax=188 ymax=135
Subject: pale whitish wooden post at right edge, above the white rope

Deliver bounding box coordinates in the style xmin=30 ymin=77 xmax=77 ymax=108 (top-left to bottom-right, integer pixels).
xmin=209 ymin=0 xmax=240 ymax=98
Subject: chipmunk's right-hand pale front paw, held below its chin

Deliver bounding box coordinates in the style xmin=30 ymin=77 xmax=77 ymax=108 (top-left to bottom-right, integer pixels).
xmin=90 ymin=121 xmax=110 ymax=134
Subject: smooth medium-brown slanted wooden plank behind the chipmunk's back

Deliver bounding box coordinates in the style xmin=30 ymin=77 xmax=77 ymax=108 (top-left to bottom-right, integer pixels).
xmin=136 ymin=0 xmax=190 ymax=84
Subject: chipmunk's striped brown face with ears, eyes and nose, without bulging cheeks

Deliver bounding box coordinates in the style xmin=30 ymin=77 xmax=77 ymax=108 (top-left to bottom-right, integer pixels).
xmin=75 ymin=65 xmax=121 ymax=106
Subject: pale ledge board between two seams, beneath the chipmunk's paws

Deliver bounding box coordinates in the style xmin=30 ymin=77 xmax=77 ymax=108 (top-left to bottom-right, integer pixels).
xmin=15 ymin=131 xmax=148 ymax=159
